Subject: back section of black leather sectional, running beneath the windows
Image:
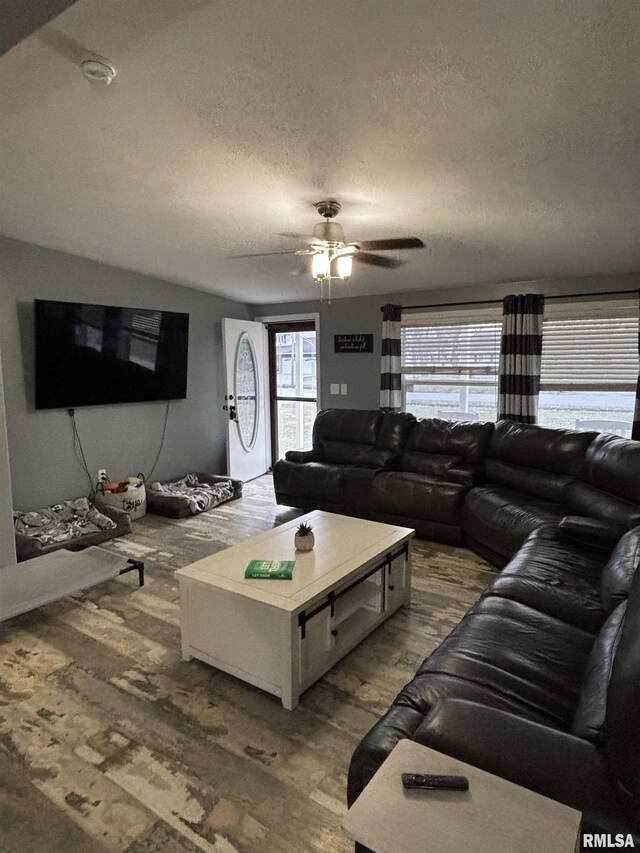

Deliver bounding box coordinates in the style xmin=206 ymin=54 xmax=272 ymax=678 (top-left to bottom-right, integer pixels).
xmin=273 ymin=409 xmax=640 ymax=566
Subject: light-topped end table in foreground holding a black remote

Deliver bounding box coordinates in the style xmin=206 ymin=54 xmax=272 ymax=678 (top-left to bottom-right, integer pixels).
xmin=342 ymin=740 xmax=581 ymax=853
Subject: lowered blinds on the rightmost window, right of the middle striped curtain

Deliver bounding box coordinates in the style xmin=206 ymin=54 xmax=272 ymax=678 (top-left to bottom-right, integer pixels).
xmin=541 ymin=297 xmax=638 ymax=391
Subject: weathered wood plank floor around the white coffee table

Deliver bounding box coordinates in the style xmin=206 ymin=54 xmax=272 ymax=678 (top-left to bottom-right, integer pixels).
xmin=0 ymin=476 xmax=493 ymax=853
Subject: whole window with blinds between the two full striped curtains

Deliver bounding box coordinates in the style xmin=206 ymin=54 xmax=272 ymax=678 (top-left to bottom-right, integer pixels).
xmin=402 ymin=305 xmax=502 ymax=420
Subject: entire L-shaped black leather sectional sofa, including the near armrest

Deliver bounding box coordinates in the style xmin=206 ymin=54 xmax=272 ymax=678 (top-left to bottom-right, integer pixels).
xmin=274 ymin=410 xmax=640 ymax=850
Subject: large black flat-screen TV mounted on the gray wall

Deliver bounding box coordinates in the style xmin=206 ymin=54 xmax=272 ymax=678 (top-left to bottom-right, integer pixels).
xmin=35 ymin=299 xmax=189 ymax=409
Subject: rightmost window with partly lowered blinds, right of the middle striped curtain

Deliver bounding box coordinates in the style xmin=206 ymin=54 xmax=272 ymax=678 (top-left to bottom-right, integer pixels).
xmin=538 ymin=297 xmax=638 ymax=437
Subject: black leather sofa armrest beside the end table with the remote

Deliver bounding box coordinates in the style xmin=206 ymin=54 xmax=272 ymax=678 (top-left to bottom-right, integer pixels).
xmin=413 ymin=699 xmax=628 ymax=831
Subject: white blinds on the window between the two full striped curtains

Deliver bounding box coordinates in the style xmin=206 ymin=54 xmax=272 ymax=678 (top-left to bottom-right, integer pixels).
xmin=402 ymin=306 xmax=502 ymax=385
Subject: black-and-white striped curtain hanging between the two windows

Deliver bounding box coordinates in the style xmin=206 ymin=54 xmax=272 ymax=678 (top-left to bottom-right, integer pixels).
xmin=498 ymin=293 xmax=544 ymax=424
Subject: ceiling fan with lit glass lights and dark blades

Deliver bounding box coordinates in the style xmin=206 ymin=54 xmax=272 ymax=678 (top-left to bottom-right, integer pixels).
xmin=231 ymin=199 xmax=424 ymax=298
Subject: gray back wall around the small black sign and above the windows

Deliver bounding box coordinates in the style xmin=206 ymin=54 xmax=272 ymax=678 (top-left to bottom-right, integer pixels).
xmin=253 ymin=273 xmax=640 ymax=409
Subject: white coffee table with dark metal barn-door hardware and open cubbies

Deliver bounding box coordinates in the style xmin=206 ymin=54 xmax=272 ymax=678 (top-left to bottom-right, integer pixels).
xmin=175 ymin=510 xmax=413 ymax=709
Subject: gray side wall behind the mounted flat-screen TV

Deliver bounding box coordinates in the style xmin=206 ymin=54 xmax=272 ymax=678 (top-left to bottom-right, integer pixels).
xmin=0 ymin=238 xmax=250 ymax=509
